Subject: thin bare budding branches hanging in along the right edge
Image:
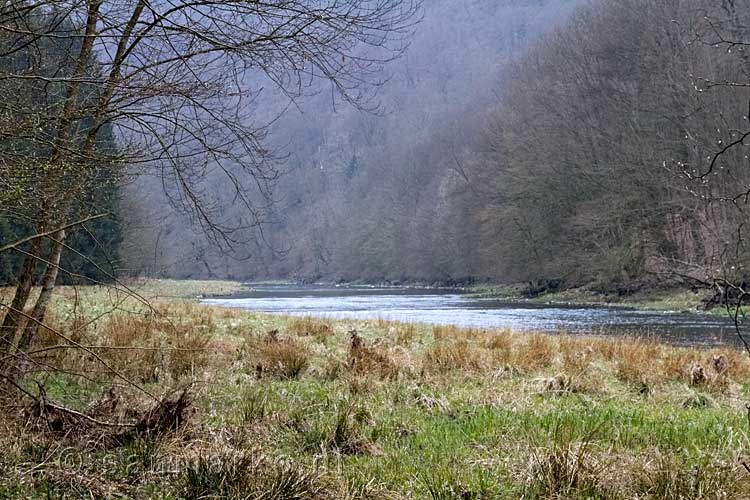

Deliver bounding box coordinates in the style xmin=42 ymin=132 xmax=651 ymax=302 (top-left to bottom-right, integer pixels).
xmin=678 ymin=0 xmax=750 ymax=352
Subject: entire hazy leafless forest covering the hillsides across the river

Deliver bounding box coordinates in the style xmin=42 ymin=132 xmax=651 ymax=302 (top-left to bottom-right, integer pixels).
xmin=23 ymin=0 xmax=750 ymax=293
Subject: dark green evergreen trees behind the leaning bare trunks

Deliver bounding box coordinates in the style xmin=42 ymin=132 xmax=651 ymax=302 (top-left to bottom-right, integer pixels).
xmin=0 ymin=11 xmax=122 ymax=286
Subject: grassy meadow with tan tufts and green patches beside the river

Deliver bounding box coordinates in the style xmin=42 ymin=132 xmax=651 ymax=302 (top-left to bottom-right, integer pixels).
xmin=0 ymin=281 xmax=750 ymax=500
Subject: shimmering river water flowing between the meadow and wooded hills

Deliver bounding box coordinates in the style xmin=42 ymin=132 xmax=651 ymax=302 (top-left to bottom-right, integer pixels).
xmin=202 ymin=285 xmax=739 ymax=346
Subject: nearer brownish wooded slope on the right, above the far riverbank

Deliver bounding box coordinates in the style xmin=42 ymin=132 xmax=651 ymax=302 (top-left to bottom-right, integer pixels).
xmin=472 ymin=0 xmax=750 ymax=288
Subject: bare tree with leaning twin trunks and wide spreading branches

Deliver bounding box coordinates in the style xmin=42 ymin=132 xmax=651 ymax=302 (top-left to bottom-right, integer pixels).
xmin=0 ymin=0 xmax=421 ymax=374
